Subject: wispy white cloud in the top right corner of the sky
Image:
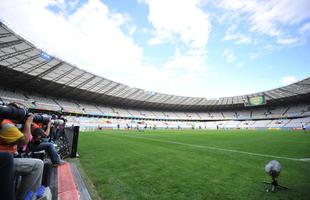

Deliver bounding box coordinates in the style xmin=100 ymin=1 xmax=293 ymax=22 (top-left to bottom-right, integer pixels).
xmin=219 ymin=0 xmax=310 ymax=37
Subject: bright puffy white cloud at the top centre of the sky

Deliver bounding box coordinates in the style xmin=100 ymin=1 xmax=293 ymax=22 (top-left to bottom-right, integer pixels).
xmin=143 ymin=0 xmax=211 ymax=48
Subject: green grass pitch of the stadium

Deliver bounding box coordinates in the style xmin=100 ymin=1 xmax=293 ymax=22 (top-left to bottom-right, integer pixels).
xmin=78 ymin=130 xmax=310 ymax=200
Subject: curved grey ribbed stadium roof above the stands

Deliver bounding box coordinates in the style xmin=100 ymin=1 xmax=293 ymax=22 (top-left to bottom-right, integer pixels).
xmin=0 ymin=22 xmax=310 ymax=110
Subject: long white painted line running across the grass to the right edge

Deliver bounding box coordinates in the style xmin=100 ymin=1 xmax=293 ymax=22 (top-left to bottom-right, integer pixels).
xmin=110 ymin=134 xmax=310 ymax=162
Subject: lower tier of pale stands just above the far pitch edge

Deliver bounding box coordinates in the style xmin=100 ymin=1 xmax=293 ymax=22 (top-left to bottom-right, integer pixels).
xmin=66 ymin=116 xmax=310 ymax=131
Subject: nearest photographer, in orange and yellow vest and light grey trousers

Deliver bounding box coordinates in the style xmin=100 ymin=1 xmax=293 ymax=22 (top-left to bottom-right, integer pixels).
xmin=0 ymin=103 xmax=44 ymax=199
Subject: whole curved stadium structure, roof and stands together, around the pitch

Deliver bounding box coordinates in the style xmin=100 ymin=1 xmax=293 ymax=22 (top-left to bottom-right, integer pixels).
xmin=0 ymin=22 xmax=310 ymax=128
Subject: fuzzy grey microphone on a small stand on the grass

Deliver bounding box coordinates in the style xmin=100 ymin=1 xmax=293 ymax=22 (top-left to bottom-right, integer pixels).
xmin=264 ymin=160 xmax=288 ymax=192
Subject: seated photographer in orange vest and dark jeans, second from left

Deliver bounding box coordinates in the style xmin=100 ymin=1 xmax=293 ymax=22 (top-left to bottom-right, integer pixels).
xmin=30 ymin=121 xmax=66 ymax=165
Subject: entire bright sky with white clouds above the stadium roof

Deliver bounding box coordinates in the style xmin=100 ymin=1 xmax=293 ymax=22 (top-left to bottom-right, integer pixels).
xmin=0 ymin=0 xmax=310 ymax=98
